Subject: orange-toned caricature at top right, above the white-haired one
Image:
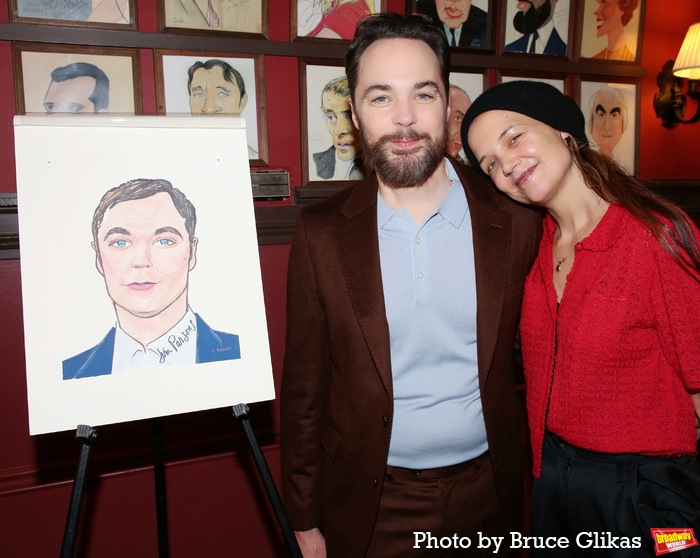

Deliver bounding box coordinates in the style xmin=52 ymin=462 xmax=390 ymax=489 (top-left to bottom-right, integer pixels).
xmin=580 ymin=0 xmax=644 ymax=62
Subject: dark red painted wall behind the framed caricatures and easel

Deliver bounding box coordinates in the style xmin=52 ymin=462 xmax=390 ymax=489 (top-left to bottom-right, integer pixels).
xmin=0 ymin=0 xmax=700 ymax=558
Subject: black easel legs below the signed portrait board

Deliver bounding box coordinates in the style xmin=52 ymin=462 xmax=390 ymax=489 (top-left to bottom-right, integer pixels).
xmin=61 ymin=404 xmax=302 ymax=558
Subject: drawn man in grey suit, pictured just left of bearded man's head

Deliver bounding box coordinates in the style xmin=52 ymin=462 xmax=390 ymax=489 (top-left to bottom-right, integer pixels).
xmin=313 ymin=76 xmax=365 ymax=180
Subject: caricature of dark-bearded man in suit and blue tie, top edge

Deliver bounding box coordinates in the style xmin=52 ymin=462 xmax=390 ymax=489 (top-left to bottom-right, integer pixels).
xmin=505 ymin=0 xmax=569 ymax=56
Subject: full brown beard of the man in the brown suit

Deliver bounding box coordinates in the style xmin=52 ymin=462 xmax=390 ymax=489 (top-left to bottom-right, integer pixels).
xmin=360 ymin=128 xmax=447 ymax=188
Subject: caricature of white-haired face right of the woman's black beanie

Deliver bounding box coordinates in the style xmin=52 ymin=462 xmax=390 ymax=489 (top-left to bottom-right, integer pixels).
xmin=580 ymin=81 xmax=639 ymax=174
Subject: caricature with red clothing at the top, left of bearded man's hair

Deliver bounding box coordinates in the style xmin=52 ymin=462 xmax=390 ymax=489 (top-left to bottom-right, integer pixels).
xmin=292 ymin=0 xmax=387 ymax=41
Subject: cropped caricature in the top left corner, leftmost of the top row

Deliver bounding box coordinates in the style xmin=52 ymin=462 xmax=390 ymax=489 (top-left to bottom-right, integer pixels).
xmin=10 ymin=0 xmax=137 ymax=30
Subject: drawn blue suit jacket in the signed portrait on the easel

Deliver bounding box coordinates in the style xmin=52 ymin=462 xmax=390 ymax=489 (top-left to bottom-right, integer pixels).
xmin=63 ymin=314 xmax=241 ymax=380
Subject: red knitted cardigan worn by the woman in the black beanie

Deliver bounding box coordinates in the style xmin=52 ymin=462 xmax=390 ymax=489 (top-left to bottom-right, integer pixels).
xmin=520 ymin=205 xmax=700 ymax=477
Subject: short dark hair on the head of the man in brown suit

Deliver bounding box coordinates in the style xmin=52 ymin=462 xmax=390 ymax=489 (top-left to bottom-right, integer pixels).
xmin=345 ymin=12 xmax=450 ymax=102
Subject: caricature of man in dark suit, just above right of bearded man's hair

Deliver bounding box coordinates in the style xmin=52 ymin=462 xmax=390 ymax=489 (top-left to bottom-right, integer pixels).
xmin=406 ymin=0 xmax=496 ymax=50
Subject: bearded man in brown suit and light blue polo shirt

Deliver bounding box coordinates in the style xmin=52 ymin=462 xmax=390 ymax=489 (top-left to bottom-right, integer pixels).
xmin=281 ymin=13 xmax=541 ymax=558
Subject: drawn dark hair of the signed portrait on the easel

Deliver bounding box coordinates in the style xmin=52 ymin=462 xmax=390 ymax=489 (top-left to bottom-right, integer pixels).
xmin=92 ymin=178 xmax=197 ymax=247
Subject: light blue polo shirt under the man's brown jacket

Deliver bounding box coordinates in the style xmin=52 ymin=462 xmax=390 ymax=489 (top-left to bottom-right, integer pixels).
xmin=377 ymin=161 xmax=488 ymax=469
